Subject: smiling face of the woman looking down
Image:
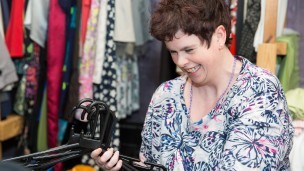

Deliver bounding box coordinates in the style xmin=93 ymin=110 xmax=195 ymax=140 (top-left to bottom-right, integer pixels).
xmin=165 ymin=31 xmax=219 ymax=85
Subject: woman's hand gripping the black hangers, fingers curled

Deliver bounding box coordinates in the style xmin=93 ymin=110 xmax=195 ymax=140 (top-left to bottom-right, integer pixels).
xmin=91 ymin=148 xmax=122 ymax=171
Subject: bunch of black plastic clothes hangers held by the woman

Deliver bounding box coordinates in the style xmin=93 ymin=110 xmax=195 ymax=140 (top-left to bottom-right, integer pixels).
xmin=1 ymin=98 xmax=166 ymax=171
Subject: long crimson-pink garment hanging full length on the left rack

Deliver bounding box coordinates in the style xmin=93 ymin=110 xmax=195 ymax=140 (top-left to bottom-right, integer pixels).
xmin=47 ymin=0 xmax=66 ymax=170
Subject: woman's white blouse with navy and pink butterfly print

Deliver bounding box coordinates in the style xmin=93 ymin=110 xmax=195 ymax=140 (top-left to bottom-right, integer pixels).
xmin=140 ymin=57 xmax=293 ymax=171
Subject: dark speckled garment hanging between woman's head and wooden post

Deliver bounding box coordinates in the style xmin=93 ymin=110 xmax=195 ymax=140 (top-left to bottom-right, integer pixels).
xmin=238 ymin=0 xmax=261 ymax=63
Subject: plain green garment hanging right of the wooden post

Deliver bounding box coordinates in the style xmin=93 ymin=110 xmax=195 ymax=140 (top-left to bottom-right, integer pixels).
xmin=277 ymin=33 xmax=300 ymax=92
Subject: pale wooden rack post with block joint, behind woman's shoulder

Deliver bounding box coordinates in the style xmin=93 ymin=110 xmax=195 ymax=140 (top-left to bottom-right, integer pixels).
xmin=257 ymin=0 xmax=287 ymax=74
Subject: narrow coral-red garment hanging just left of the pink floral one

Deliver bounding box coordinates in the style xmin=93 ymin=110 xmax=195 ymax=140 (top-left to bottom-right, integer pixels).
xmin=81 ymin=0 xmax=91 ymax=46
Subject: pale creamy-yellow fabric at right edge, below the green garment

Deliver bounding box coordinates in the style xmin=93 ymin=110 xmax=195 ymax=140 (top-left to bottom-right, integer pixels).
xmin=285 ymin=88 xmax=304 ymax=120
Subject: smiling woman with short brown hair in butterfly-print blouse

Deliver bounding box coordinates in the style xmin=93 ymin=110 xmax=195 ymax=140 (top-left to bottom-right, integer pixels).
xmin=91 ymin=0 xmax=293 ymax=170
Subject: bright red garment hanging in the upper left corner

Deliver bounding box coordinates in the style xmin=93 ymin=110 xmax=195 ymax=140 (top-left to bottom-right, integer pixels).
xmin=5 ymin=0 xmax=24 ymax=58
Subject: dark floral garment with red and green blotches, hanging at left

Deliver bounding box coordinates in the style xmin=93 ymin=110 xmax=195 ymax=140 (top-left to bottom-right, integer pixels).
xmin=14 ymin=29 xmax=45 ymax=155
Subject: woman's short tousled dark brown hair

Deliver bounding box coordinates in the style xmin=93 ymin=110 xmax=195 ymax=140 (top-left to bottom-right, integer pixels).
xmin=150 ymin=0 xmax=231 ymax=47
